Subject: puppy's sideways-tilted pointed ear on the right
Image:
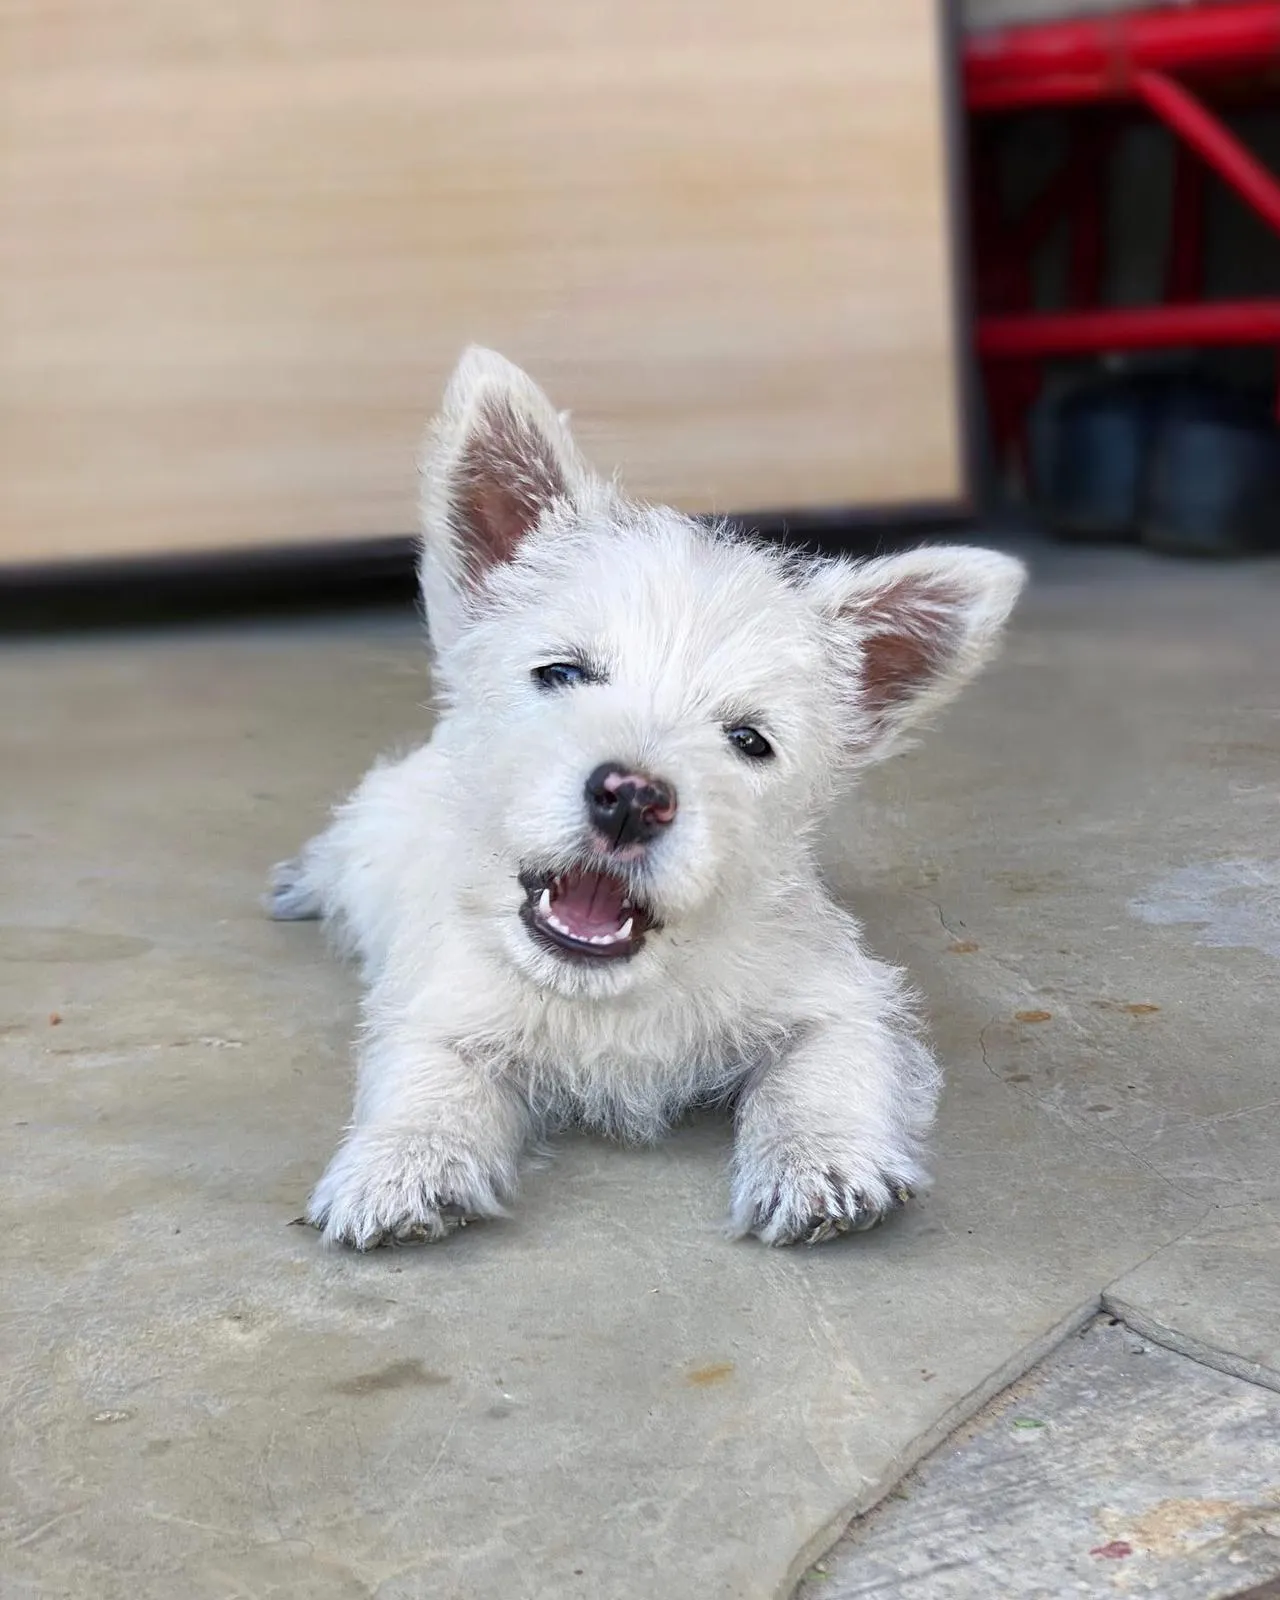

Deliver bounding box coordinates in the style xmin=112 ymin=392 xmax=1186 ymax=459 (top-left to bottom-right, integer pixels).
xmin=808 ymin=547 xmax=1027 ymax=762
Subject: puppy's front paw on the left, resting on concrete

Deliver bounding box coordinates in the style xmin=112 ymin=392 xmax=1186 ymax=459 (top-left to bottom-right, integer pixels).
xmin=307 ymin=1131 xmax=506 ymax=1250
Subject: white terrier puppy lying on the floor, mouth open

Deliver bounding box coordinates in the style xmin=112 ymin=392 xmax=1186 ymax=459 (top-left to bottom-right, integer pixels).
xmin=269 ymin=349 xmax=1026 ymax=1250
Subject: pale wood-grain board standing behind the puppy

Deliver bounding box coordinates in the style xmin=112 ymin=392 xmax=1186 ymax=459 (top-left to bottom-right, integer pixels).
xmin=0 ymin=0 xmax=963 ymax=563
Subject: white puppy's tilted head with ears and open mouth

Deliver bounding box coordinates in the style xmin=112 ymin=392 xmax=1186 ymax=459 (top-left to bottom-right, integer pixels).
xmin=421 ymin=350 xmax=1024 ymax=995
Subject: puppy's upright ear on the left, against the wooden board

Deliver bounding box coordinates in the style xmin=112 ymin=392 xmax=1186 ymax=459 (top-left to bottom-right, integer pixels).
xmin=418 ymin=346 xmax=590 ymax=650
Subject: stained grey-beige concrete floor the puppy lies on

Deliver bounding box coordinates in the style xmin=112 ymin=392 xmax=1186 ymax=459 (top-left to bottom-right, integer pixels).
xmin=0 ymin=550 xmax=1280 ymax=1600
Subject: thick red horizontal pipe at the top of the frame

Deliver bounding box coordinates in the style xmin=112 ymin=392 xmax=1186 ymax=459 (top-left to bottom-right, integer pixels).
xmin=965 ymin=0 xmax=1280 ymax=110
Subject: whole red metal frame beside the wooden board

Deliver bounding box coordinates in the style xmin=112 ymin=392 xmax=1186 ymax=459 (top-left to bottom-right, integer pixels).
xmin=965 ymin=0 xmax=1280 ymax=460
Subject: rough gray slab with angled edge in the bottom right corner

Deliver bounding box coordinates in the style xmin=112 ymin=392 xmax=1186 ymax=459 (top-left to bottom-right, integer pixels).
xmin=798 ymin=1318 xmax=1280 ymax=1600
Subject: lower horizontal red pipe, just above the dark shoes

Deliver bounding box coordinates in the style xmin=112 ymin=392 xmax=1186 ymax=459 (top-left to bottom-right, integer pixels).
xmin=978 ymin=301 xmax=1280 ymax=362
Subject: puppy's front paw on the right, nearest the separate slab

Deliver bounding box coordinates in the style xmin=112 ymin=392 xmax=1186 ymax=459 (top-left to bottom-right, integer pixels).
xmin=733 ymin=1154 xmax=918 ymax=1245
